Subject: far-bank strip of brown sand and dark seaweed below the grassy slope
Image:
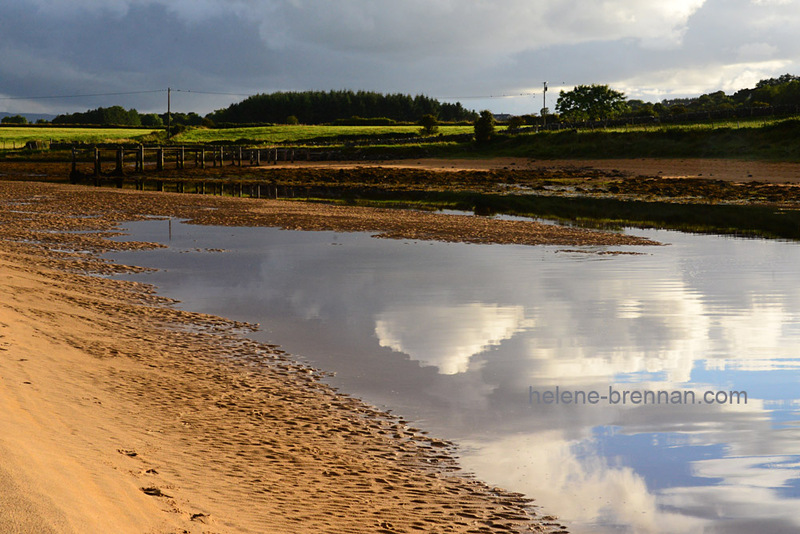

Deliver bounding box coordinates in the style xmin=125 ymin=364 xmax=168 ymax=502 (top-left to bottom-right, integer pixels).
xmin=7 ymin=158 xmax=800 ymax=208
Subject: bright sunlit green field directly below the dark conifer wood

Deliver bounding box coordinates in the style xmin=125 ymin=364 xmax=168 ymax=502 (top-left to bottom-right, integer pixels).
xmin=173 ymin=124 xmax=473 ymax=144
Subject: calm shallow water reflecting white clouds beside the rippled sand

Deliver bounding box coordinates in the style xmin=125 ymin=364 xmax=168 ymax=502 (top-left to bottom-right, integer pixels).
xmin=113 ymin=221 xmax=800 ymax=533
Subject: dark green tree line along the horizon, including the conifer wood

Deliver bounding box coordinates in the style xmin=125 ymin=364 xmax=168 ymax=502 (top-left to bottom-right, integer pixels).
xmin=18 ymin=74 xmax=800 ymax=131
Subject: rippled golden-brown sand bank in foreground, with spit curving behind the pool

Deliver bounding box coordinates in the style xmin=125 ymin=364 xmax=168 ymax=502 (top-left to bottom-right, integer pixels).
xmin=0 ymin=182 xmax=664 ymax=533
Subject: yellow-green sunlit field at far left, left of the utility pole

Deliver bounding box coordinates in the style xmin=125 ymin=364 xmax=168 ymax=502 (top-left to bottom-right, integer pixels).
xmin=0 ymin=126 xmax=161 ymax=149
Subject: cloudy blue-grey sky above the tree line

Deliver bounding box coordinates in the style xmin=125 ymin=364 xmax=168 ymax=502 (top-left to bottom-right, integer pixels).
xmin=0 ymin=0 xmax=800 ymax=115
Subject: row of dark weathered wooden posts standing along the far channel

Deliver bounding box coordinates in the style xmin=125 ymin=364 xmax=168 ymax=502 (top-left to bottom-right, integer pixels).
xmin=72 ymin=145 xmax=318 ymax=176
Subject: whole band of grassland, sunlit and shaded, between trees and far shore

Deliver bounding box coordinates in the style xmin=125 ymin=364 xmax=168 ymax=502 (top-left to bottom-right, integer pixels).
xmin=0 ymin=119 xmax=800 ymax=161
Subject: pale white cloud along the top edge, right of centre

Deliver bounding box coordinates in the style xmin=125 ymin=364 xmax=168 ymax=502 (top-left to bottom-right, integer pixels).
xmin=245 ymin=0 xmax=703 ymax=55
